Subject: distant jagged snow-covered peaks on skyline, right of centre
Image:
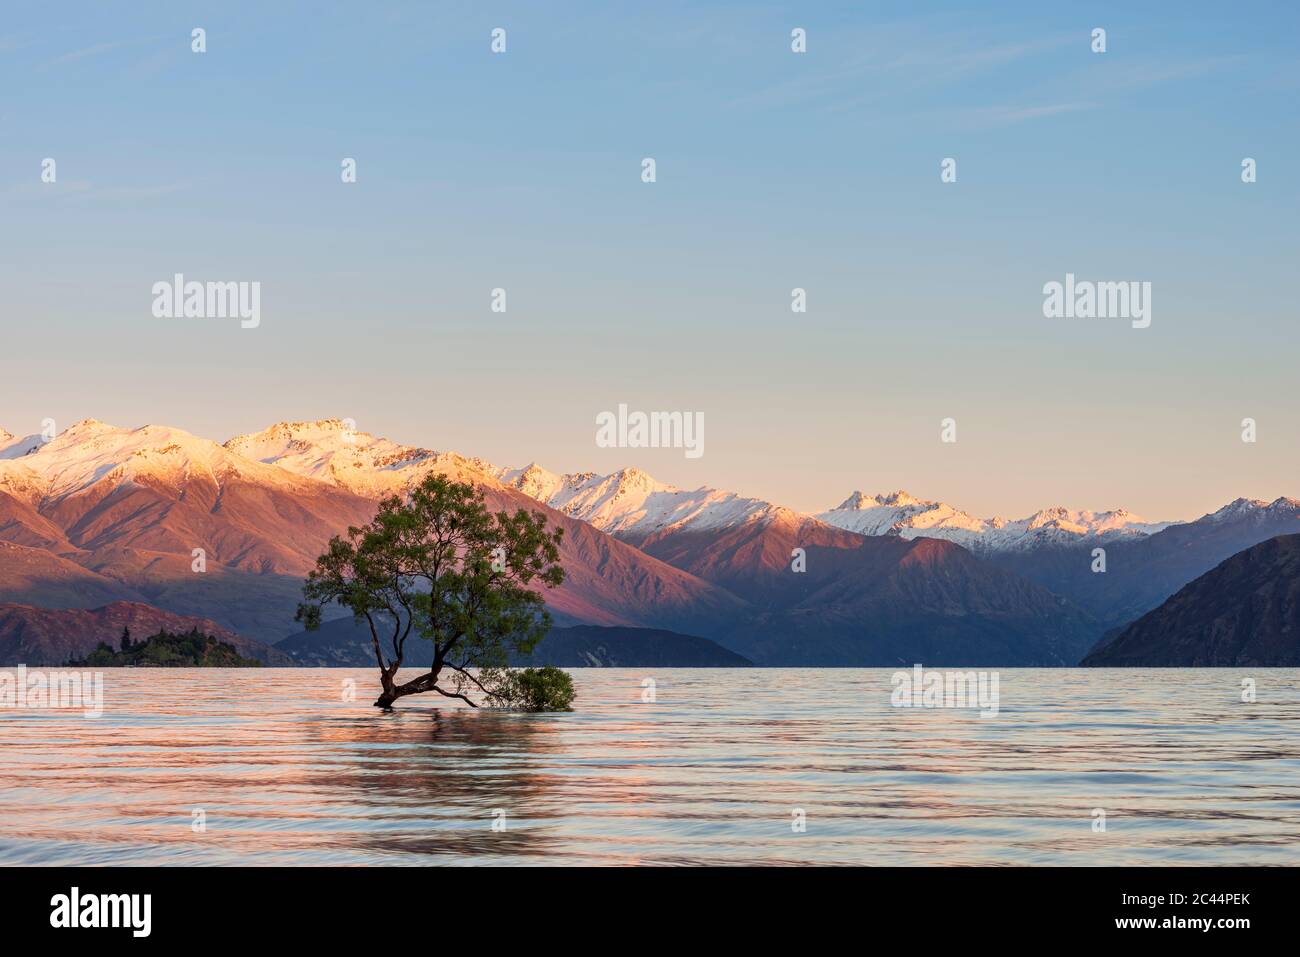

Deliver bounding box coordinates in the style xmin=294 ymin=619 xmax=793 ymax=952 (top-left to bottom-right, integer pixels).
xmin=816 ymin=492 xmax=1173 ymax=553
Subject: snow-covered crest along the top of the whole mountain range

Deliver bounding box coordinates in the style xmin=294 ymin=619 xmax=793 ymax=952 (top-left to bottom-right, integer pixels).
xmin=0 ymin=419 xmax=1300 ymax=551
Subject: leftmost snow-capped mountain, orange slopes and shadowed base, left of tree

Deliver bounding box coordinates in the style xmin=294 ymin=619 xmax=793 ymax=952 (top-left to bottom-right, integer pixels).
xmin=0 ymin=419 xmax=384 ymax=640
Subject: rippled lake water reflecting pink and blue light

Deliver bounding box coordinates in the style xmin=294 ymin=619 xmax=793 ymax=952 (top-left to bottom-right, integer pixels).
xmin=0 ymin=668 xmax=1300 ymax=865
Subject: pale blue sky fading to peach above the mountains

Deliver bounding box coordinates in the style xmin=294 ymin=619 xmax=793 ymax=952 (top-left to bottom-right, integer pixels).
xmin=0 ymin=3 xmax=1300 ymax=519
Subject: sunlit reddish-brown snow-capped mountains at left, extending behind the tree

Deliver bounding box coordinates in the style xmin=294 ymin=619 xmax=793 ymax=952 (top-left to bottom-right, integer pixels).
xmin=0 ymin=420 xmax=745 ymax=641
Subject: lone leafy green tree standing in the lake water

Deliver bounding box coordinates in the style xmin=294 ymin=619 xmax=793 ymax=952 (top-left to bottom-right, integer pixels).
xmin=298 ymin=475 xmax=573 ymax=710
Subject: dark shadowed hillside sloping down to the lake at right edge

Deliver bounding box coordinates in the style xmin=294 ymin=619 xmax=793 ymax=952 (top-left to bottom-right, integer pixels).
xmin=1083 ymin=534 xmax=1300 ymax=667
